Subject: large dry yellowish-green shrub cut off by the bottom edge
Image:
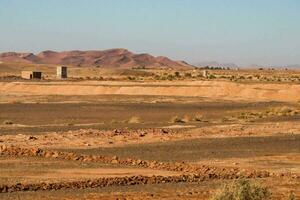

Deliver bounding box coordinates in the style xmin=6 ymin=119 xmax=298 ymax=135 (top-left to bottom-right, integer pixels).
xmin=211 ymin=180 xmax=271 ymax=200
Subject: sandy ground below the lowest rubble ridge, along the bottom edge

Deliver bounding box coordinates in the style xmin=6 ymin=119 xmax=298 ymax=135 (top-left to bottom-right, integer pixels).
xmin=0 ymin=179 xmax=300 ymax=200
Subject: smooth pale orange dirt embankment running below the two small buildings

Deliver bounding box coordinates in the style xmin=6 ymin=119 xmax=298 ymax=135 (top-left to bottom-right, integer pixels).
xmin=0 ymin=81 xmax=300 ymax=102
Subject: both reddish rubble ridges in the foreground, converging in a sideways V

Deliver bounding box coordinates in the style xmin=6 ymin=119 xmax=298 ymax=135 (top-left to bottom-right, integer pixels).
xmin=0 ymin=145 xmax=286 ymax=193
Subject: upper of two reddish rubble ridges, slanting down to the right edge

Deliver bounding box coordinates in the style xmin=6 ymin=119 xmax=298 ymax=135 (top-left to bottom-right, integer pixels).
xmin=0 ymin=145 xmax=299 ymax=179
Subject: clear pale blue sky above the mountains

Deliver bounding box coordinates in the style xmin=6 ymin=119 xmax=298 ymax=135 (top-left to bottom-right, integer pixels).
xmin=0 ymin=0 xmax=300 ymax=65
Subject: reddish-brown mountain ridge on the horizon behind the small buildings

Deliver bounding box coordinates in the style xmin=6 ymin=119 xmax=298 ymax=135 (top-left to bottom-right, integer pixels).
xmin=0 ymin=49 xmax=193 ymax=69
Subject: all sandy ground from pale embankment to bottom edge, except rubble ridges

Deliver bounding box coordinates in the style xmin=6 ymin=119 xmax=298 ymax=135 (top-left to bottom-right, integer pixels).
xmin=0 ymin=81 xmax=300 ymax=199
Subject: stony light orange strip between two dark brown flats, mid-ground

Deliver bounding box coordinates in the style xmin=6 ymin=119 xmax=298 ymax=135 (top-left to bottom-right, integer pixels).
xmin=0 ymin=122 xmax=300 ymax=149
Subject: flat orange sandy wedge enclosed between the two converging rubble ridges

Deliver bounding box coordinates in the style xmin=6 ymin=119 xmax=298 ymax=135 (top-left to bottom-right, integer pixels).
xmin=0 ymin=157 xmax=180 ymax=184
